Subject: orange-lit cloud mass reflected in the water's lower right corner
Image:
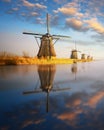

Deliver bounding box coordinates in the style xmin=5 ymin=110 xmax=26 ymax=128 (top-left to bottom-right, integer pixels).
xmin=55 ymin=90 xmax=104 ymax=130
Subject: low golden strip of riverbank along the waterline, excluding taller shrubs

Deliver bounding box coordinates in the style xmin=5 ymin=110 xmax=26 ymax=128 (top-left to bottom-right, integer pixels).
xmin=0 ymin=57 xmax=92 ymax=65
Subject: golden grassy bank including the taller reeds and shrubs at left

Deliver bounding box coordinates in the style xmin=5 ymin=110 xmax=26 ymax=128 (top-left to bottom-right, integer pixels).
xmin=0 ymin=52 xmax=92 ymax=65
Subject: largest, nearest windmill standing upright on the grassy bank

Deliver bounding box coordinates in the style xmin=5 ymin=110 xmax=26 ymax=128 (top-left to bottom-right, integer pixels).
xmin=23 ymin=13 xmax=70 ymax=59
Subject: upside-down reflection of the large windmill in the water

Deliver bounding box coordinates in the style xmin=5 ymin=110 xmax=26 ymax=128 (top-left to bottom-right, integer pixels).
xmin=23 ymin=65 xmax=70 ymax=112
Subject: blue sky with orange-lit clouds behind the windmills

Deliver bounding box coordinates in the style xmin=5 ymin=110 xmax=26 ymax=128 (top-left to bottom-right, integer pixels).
xmin=0 ymin=0 xmax=104 ymax=59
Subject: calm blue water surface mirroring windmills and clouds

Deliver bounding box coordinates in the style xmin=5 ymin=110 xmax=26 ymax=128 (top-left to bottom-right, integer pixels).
xmin=0 ymin=61 xmax=104 ymax=130
